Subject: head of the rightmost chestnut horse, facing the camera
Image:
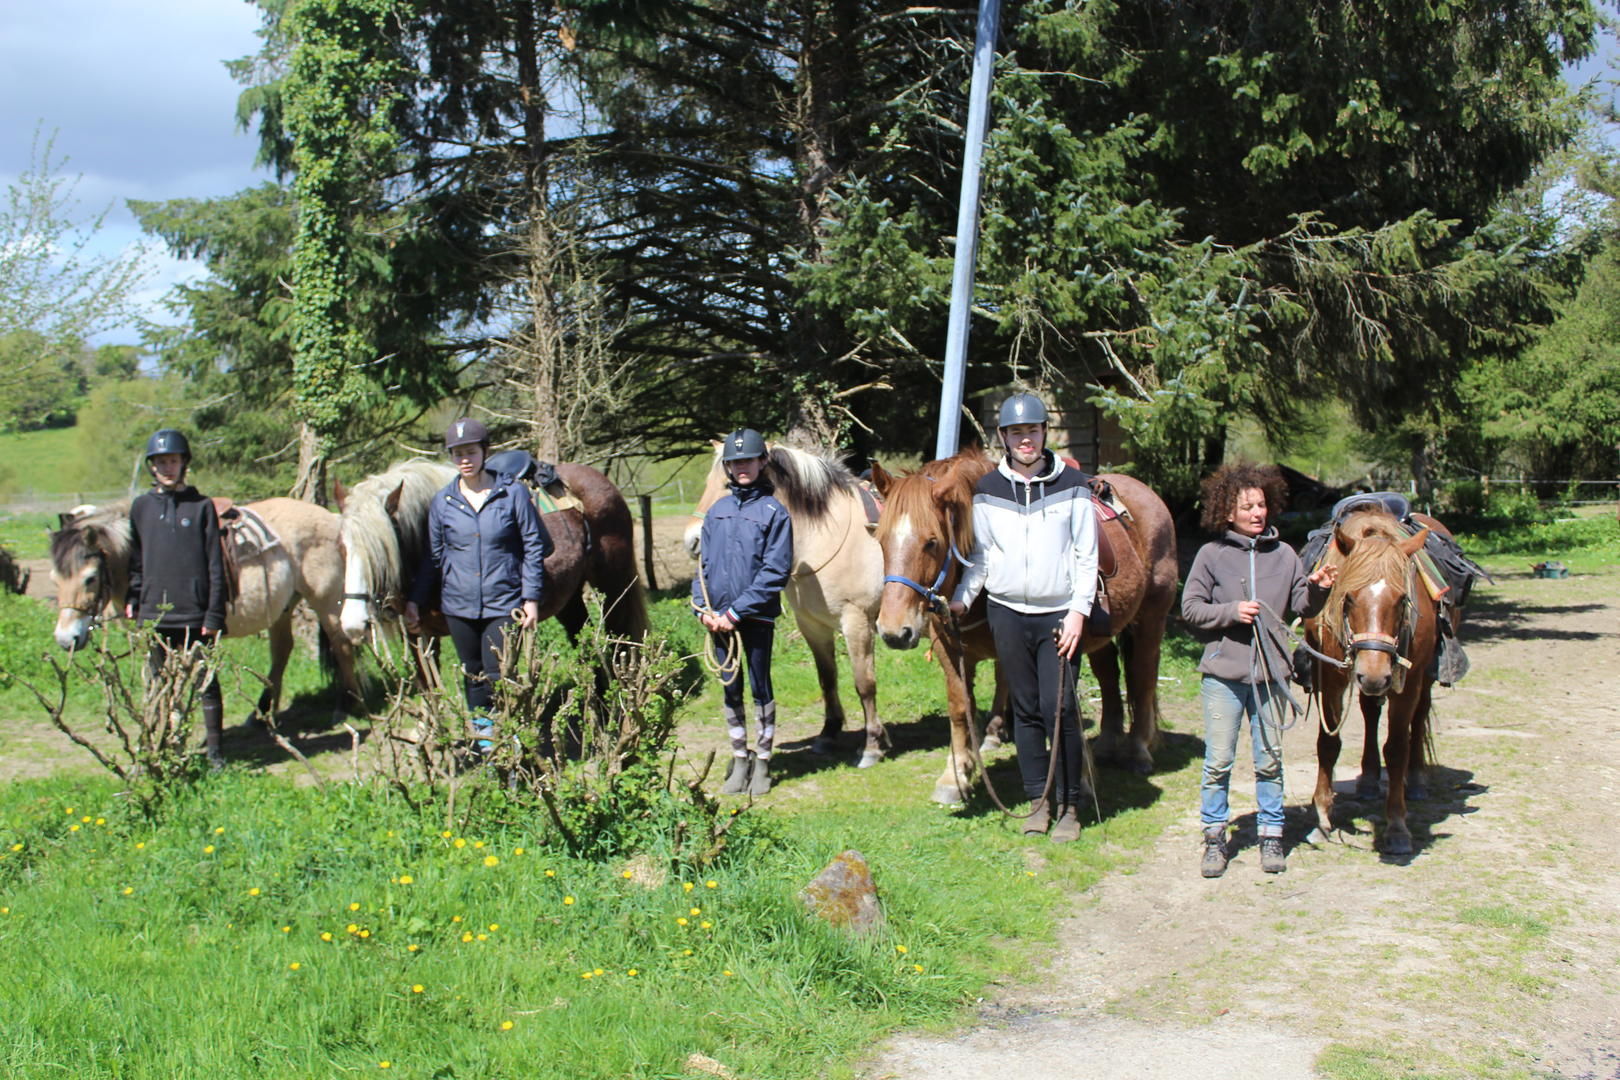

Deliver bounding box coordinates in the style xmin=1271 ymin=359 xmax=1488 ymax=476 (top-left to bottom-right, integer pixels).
xmin=1320 ymin=513 xmax=1429 ymax=698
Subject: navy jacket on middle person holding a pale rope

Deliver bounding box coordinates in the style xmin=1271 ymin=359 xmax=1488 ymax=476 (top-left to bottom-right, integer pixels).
xmin=692 ymin=484 xmax=794 ymax=622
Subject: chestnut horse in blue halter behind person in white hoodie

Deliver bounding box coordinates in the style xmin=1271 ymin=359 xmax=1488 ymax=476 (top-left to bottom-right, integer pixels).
xmin=872 ymin=449 xmax=1176 ymax=803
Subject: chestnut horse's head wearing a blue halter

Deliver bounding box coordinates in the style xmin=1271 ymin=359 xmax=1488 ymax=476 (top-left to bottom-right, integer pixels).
xmin=872 ymin=455 xmax=990 ymax=649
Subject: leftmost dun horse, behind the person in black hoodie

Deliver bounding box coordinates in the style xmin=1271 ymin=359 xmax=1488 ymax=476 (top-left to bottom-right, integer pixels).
xmin=50 ymin=499 xmax=361 ymax=717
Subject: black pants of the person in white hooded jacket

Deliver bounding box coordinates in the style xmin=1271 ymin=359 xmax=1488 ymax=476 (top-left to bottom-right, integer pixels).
xmin=988 ymin=601 xmax=1084 ymax=806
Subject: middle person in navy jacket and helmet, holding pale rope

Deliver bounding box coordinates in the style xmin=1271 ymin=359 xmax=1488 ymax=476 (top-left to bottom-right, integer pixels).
xmin=692 ymin=427 xmax=794 ymax=795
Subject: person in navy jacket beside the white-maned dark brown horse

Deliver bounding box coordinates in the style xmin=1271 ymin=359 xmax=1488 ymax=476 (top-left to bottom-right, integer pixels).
xmin=405 ymin=419 xmax=551 ymax=750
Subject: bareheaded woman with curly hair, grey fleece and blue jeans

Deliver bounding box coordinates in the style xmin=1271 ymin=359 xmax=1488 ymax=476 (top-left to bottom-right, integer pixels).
xmin=1181 ymin=463 xmax=1338 ymax=878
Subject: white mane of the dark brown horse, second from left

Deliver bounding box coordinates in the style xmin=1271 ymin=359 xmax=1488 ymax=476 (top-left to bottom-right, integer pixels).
xmin=342 ymin=458 xmax=455 ymax=596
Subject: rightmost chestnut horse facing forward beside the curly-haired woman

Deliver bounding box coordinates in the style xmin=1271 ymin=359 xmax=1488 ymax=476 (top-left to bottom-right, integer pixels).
xmin=1306 ymin=510 xmax=1443 ymax=855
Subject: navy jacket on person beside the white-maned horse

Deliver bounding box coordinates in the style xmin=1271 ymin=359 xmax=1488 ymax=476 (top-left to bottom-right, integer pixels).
xmin=411 ymin=476 xmax=551 ymax=619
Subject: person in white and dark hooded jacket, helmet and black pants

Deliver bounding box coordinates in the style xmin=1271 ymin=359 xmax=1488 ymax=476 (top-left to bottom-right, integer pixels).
xmin=951 ymin=393 xmax=1097 ymax=842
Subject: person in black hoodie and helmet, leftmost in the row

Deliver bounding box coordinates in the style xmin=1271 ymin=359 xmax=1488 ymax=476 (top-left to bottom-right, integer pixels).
xmin=125 ymin=427 xmax=225 ymax=769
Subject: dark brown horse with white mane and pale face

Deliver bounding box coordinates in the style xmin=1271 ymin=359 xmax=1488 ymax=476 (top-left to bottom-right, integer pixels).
xmin=335 ymin=460 xmax=646 ymax=641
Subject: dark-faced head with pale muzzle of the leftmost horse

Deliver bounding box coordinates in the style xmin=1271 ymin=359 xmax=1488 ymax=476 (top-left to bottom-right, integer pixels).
xmin=50 ymin=507 xmax=130 ymax=649
